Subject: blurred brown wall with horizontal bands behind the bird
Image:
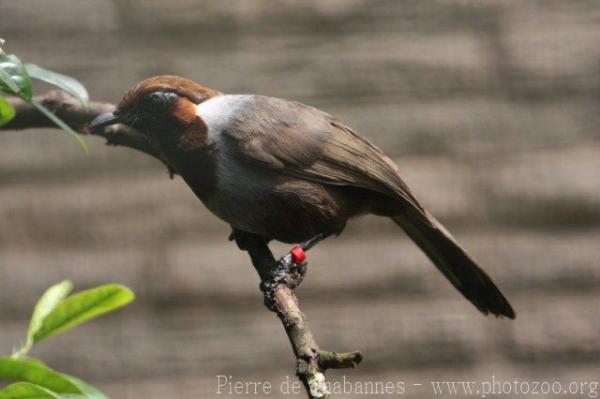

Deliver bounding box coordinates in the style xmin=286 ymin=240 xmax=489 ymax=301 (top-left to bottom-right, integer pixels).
xmin=0 ymin=0 xmax=600 ymax=399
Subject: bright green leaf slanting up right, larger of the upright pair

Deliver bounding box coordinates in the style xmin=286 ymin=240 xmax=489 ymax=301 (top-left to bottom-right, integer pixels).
xmin=33 ymin=284 xmax=135 ymax=342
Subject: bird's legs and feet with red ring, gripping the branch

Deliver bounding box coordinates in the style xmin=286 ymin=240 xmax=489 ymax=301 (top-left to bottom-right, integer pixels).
xmin=229 ymin=228 xmax=329 ymax=309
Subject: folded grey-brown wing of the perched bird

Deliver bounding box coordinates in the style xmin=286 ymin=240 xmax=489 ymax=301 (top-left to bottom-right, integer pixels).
xmin=223 ymin=96 xmax=422 ymax=210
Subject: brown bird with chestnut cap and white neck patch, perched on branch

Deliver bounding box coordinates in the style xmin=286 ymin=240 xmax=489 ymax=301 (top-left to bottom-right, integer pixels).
xmin=90 ymin=75 xmax=515 ymax=319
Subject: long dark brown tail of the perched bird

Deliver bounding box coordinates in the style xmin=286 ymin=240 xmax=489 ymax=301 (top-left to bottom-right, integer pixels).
xmin=392 ymin=207 xmax=515 ymax=319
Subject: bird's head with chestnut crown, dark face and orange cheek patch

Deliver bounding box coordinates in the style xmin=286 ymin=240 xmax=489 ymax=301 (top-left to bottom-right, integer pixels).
xmin=90 ymin=75 xmax=221 ymax=133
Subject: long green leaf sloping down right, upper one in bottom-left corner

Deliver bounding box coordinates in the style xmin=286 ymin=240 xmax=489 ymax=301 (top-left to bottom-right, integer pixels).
xmin=0 ymin=357 xmax=108 ymax=399
